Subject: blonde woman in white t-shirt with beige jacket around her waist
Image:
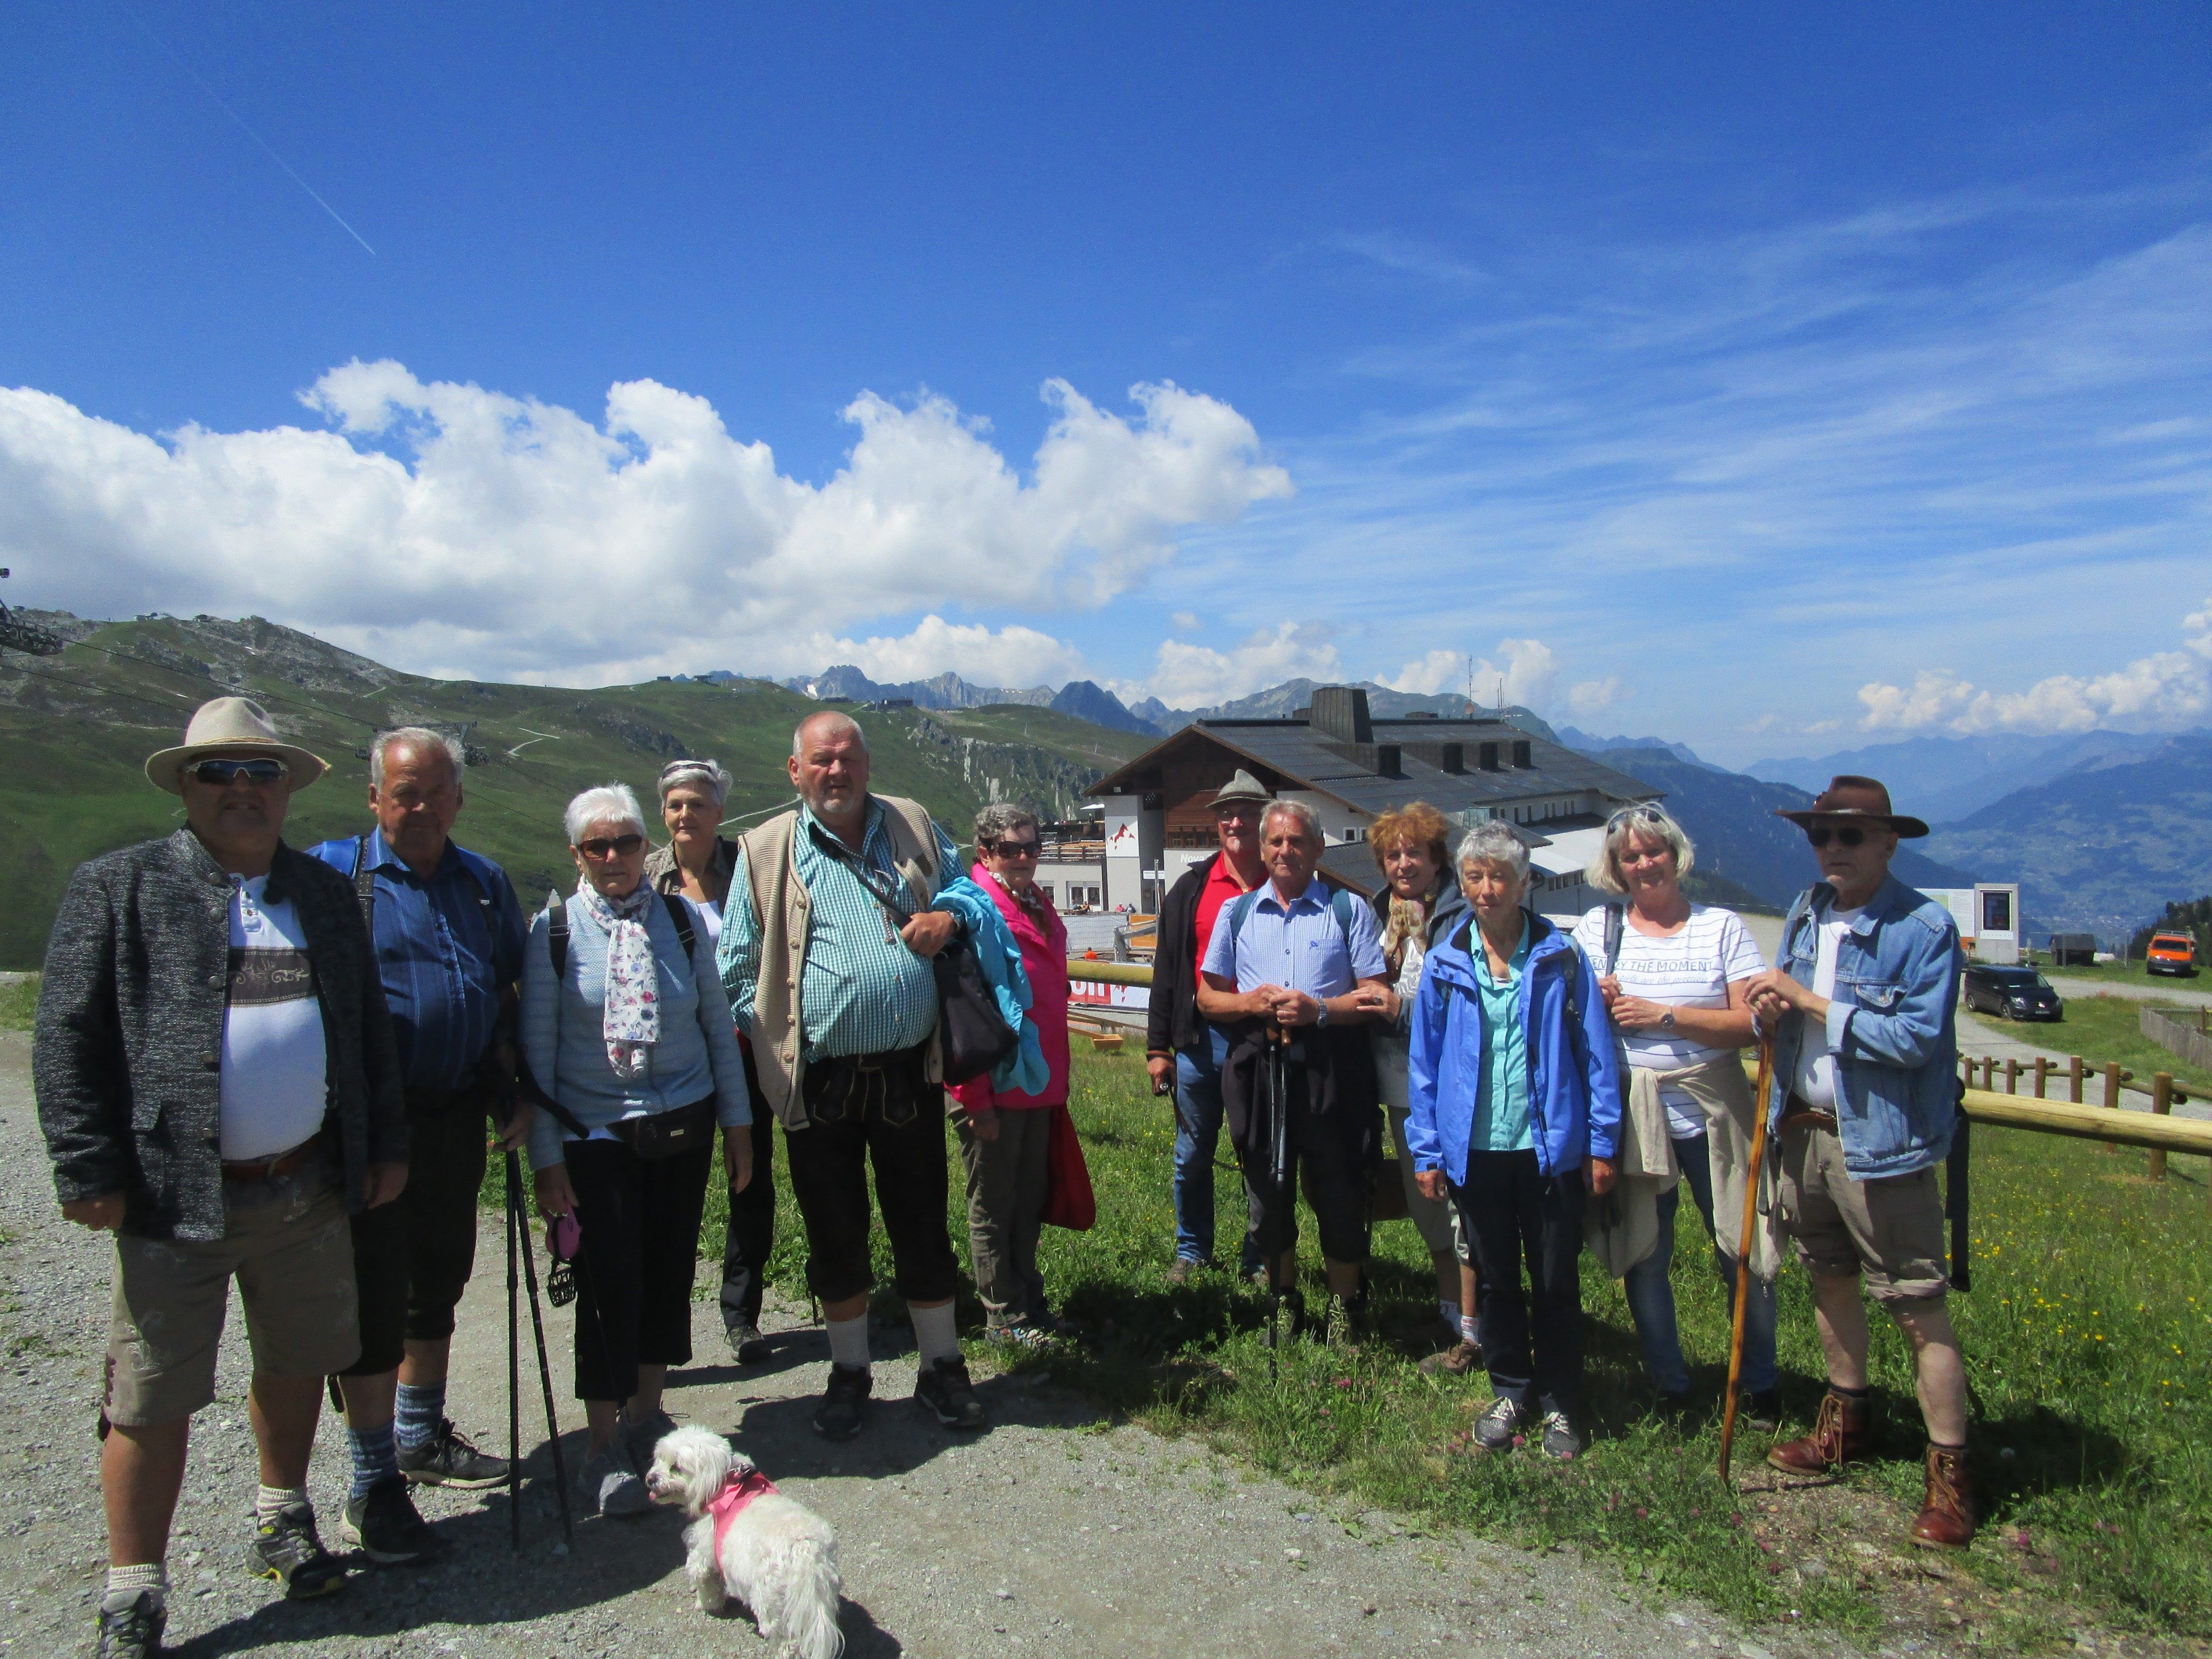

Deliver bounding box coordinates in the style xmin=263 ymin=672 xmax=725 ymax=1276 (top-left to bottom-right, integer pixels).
xmin=1575 ymin=805 xmax=1781 ymax=1427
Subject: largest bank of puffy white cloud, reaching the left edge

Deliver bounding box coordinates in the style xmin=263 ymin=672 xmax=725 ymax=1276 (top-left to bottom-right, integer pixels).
xmin=0 ymin=361 xmax=1290 ymax=684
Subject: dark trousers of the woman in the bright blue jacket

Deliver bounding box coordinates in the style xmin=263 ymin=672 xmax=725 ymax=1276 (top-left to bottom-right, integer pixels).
xmin=1451 ymin=1150 xmax=1584 ymax=1411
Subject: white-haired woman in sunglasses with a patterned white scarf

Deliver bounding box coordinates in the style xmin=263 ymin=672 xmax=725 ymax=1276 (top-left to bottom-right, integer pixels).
xmin=522 ymin=783 xmax=752 ymax=1515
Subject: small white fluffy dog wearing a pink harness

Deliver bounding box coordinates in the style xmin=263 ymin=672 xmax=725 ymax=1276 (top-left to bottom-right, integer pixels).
xmin=646 ymin=1427 xmax=845 ymax=1659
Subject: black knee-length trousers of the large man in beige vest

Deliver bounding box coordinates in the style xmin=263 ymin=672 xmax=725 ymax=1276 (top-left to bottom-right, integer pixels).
xmin=783 ymin=1049 xmax=960 ymax=1303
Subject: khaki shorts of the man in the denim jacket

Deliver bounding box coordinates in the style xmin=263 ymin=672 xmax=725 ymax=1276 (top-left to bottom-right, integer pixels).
xmin=1781 ymin=1124 xmax=1951 ymax=1303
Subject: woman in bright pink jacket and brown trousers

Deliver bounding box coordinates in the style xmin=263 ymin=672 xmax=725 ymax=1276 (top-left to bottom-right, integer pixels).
xmin=953 ymin=803 xmax=1068 ymax=1345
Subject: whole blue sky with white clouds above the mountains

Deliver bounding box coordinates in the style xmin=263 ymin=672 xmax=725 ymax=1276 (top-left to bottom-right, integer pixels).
xmin=0 ymin=0 xmax=2212 ymax=761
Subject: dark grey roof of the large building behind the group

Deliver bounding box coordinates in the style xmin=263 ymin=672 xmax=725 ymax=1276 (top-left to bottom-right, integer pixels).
xmin=1092 ymin=719 xmax=1665 ymax=814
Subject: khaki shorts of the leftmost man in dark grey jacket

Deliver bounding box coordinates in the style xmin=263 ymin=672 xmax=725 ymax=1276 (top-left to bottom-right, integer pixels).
xmin=106 ymin=1159 xmax=361 ymax=1427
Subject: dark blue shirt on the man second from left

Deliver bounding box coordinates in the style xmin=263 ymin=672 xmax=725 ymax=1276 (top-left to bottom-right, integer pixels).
xmin=307 ymin=830 xmax=524 ymax=1088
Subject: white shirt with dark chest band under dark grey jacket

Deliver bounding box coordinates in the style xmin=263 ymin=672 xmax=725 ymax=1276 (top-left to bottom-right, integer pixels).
xmin=221 ymin=876 xmax=329 ymax=1159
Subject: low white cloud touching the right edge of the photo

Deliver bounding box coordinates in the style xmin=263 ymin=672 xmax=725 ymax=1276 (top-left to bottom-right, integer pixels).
xmin=1858 ymin=599 xmax=2212 ymax=732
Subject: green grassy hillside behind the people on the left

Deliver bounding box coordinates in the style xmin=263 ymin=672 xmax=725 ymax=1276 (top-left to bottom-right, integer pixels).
xmin=0 ymin=617 xmax=1144 ymax=967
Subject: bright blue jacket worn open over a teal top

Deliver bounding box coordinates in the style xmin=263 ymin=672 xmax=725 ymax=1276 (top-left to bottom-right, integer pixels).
xmin=1405 ymin=912 xmax=1621 ymax=1185
